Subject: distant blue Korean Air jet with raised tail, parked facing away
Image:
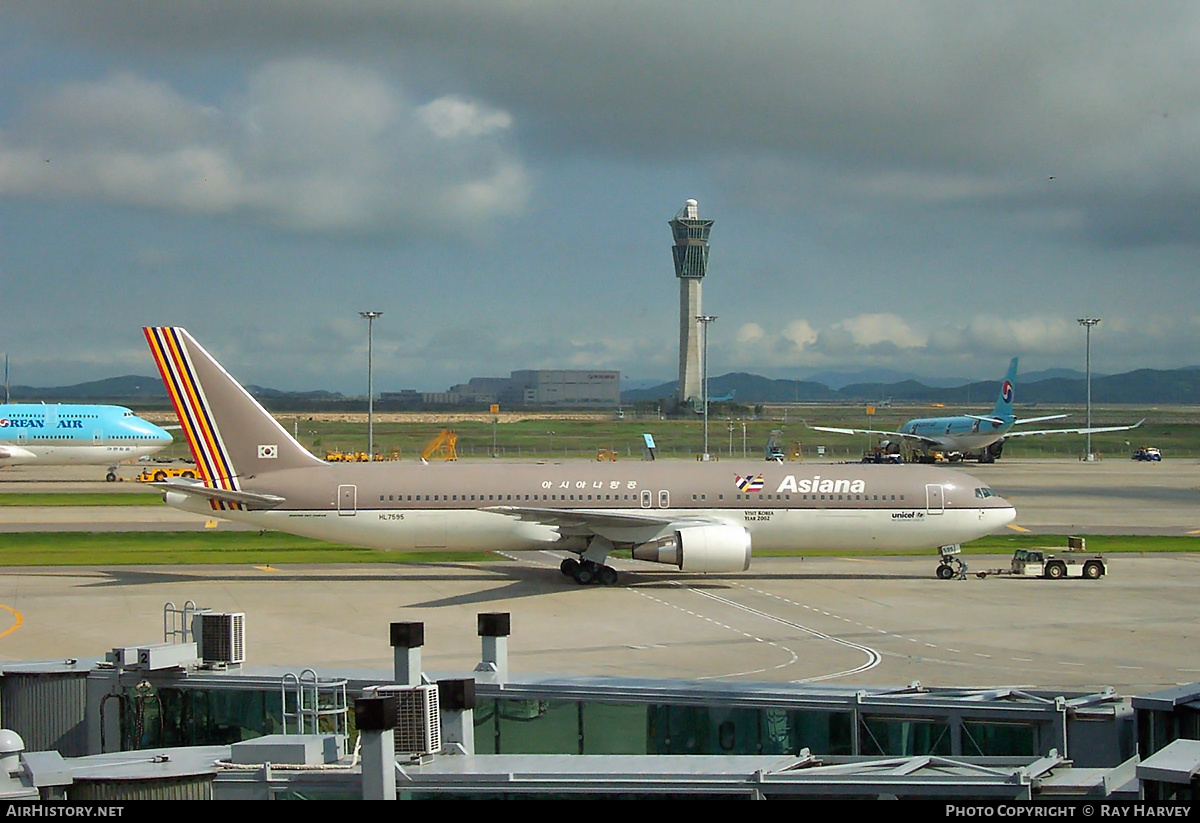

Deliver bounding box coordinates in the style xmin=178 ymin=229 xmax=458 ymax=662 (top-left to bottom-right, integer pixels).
xmin=810 ymin=358 xmax=1145 ymax=463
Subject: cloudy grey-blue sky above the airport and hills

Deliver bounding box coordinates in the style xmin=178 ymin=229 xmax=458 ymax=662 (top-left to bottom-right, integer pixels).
xmin=0 ymin=0 xmax=1200 ymax=394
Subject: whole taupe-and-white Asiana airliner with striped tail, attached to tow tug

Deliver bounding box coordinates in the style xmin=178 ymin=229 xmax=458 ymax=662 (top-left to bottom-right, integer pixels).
xmin=144 ymin=328 xmax=1015 ymax=585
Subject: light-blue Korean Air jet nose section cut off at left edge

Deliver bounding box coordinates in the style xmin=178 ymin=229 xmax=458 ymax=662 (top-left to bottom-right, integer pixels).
xmin=0 ymin=403 xmax=173 ymax=481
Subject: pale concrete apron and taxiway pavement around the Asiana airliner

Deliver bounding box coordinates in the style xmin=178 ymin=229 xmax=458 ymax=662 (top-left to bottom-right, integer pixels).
xmin=0 ymin=461 xmax=1200 ymax=693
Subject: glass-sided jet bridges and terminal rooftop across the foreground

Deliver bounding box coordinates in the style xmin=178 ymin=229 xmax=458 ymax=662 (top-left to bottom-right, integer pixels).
xmin=0 ymin=602 xmax=1200 ymax=803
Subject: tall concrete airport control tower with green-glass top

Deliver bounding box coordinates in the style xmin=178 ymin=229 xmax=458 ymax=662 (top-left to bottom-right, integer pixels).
xmin=671 ymin=200 xmax=713 ymax=407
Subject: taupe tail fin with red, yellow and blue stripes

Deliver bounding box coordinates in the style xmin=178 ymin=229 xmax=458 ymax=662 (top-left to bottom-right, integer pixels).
xmin=143 ymin=326 xmax=322 ymax=499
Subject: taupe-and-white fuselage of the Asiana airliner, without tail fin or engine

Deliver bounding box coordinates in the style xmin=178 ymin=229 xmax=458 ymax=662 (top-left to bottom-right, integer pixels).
xmin=166 ymin=461 xmax=1015 ymax=551
